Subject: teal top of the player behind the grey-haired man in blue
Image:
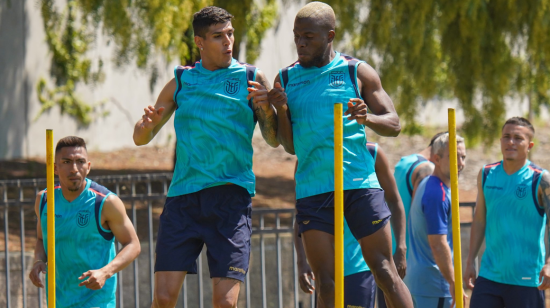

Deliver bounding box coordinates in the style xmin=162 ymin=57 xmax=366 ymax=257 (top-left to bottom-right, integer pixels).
xmin=391 ymin=154 xmax=431 ymax=255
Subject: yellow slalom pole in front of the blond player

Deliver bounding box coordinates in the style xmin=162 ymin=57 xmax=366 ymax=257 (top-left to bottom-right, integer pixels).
xmin=334 ymin=103 xmax=344 ymax=308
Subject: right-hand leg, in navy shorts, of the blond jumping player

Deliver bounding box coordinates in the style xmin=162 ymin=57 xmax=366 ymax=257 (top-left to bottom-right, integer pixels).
xmin=344 ymin=189 xmax=413 ymax=308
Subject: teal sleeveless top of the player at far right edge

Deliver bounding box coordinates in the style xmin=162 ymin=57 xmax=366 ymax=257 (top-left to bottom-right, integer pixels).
xmin=479 ymin=161 xmax=547 ymax=287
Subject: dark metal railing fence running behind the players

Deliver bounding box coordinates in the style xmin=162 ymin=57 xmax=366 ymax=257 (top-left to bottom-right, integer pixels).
xmin=0 ymin=173 xmax=474 ymax=308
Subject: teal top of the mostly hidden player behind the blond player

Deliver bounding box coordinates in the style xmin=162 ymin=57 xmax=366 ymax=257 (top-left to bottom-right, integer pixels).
xmin=344 ymin=142 xmax=378 ymax=276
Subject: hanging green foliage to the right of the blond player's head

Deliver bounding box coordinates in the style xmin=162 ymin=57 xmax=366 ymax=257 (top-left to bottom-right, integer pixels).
xmin=326 ymin=0 xmax=550 ymax=143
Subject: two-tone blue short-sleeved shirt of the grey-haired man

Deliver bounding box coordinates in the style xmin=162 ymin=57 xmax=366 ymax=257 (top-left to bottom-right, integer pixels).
xmin=404 ymin=175 xmax=453 ymax=297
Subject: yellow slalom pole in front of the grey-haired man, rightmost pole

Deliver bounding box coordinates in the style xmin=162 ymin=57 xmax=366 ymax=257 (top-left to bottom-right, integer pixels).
xmin=449 ymin=108 xmax=464 ymax=308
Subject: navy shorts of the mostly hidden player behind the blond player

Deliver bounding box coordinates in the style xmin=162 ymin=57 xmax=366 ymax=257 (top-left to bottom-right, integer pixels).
xmin=344 ymin=271 xmax=376 ymax=308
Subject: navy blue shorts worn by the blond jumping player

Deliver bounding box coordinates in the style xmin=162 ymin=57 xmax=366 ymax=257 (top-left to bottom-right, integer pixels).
xmin=296 ymin=188 xmax=391 ymax=240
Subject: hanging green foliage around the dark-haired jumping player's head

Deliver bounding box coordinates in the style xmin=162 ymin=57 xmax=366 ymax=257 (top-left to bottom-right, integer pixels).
xmin=37 ymin=0 xmax=277 ymax=126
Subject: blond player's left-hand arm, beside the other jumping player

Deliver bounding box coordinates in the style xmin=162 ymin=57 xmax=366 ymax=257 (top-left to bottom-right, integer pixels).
xmin=268 ymin=74 xmax=294 ymax=155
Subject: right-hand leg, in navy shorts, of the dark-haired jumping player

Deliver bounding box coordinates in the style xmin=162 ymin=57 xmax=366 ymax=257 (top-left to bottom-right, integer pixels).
xmin=200 ymin=185 xmax=252 ymax=308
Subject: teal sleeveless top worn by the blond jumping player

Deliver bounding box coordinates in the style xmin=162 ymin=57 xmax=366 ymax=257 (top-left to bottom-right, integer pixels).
xmin=279 ymin=52 xmax=380 ymax=199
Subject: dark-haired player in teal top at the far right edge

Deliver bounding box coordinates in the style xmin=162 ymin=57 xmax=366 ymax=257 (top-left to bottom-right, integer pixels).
xmin=464 ymin=117 xmax=550 ymax=308
